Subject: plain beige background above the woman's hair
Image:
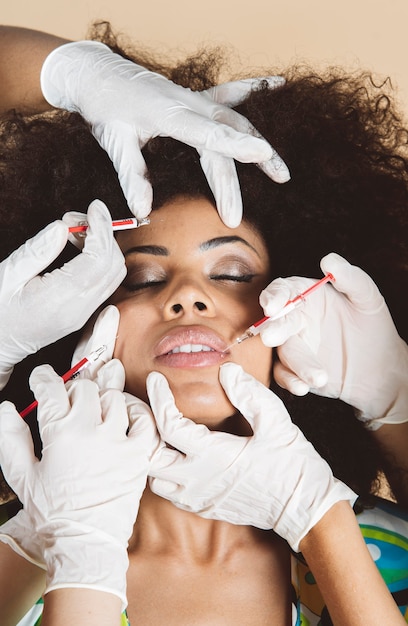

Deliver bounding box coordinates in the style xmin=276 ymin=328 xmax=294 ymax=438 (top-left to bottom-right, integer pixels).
xmin=0 ymin=0 xmax=408 ymax=112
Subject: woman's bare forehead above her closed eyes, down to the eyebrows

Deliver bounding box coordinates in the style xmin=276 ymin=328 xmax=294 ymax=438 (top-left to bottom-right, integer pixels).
xmin=117 ymin=198 xmax=268 ymax=263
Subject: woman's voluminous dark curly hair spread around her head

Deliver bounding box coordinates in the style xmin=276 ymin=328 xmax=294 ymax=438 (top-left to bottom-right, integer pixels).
xmin=0 ymin=23 xmax=408 ymax=496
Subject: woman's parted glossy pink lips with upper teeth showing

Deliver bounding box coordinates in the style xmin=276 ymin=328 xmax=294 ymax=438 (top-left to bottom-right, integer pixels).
xmin=154 ymin=326 xmax=227 ymax=367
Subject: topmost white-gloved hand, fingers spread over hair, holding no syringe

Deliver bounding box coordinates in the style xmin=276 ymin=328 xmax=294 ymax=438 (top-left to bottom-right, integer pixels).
xmin=41 ymin=41 xmax=289 ymax=227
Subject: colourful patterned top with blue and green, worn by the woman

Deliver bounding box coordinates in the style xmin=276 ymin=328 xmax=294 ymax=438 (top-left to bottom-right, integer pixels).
xmin=0 ymin=499 xmax=408 ymax=626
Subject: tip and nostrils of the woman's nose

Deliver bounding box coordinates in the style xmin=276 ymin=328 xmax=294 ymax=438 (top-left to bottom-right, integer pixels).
xmin=164 ymin=278 xmax=215 ymax=319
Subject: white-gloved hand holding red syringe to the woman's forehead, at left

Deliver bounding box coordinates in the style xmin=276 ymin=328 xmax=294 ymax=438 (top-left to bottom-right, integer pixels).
xmin=0 ymin=200 xmax=126 ymax=389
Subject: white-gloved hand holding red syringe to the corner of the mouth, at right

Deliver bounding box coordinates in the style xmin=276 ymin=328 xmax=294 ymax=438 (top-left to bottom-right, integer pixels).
xmin=260 ymin=253 xmax=408 ymax=430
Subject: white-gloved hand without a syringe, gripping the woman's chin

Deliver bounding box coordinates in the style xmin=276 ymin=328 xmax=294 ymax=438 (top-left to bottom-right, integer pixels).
xmin=147 ymin=363 xmax=357 ymax=551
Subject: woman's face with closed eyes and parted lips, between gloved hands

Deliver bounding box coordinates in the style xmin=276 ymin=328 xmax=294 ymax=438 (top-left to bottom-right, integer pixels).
xmin=111 ymin=198 xmax=272 ymax=427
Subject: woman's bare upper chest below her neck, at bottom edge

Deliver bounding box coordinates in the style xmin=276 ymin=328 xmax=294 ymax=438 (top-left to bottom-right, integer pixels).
xmin=128 ymin=532 xmax=292 ymax=626
